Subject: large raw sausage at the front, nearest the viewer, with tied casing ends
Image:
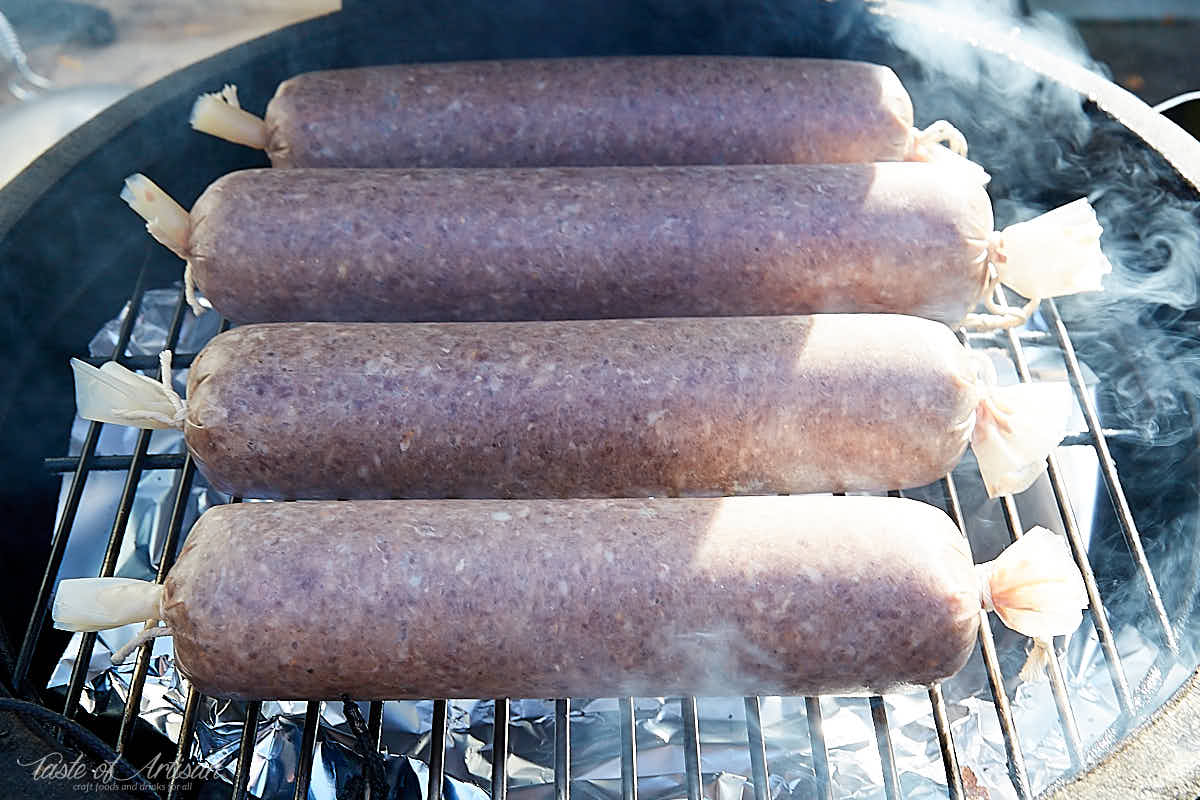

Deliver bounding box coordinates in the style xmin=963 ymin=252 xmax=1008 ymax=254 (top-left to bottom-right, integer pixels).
xmin=54 ymin=497 xmax=1087 ymax=700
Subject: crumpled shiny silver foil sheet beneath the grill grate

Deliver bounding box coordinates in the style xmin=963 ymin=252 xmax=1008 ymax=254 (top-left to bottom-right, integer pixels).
xmin=49 ymin=290 xmax=1195 ymax=800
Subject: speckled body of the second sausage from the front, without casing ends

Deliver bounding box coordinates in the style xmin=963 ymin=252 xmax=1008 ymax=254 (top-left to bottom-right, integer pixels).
xmin=184 ymin=314 xmax=980 ymax=499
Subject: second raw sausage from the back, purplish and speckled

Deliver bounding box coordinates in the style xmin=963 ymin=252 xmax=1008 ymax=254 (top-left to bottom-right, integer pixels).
xmin=127 ymin=163 xmax=992 ymax=324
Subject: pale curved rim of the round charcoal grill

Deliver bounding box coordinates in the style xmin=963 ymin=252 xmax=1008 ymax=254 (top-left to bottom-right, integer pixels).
xmin=0 ymin=0 xmax=1200 ymax=799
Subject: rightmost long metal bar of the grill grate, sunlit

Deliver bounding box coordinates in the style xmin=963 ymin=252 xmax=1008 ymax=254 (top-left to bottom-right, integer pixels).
xmin=1042 ymin=300 xmax=1180 ymax=656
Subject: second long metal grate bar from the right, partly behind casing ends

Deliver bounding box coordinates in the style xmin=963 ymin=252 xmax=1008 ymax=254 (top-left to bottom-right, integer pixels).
xmin=996 ymin=292 xmax=1140 ymax=717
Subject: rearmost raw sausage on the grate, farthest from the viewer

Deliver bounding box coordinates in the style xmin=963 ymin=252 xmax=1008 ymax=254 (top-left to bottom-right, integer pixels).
xmin=192 ymin=56 xmax=945 ymax=167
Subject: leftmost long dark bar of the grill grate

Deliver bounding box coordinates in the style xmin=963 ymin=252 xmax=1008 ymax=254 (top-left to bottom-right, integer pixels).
xmin=12 ymin=261 xmax=149 ymax=694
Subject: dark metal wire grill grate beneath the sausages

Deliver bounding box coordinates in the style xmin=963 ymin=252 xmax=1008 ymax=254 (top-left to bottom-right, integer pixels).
xmin=13 ymin=263 xmax=1178 ymax=800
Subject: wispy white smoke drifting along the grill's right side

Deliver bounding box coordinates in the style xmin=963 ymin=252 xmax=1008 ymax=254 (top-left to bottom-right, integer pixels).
xmin=852 ymin=2 xmax=1200 ymax=753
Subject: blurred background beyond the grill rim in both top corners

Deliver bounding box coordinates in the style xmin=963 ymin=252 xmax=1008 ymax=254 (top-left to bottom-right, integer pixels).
xmin=0 ymin=0 xmax=1200 ymax=185
